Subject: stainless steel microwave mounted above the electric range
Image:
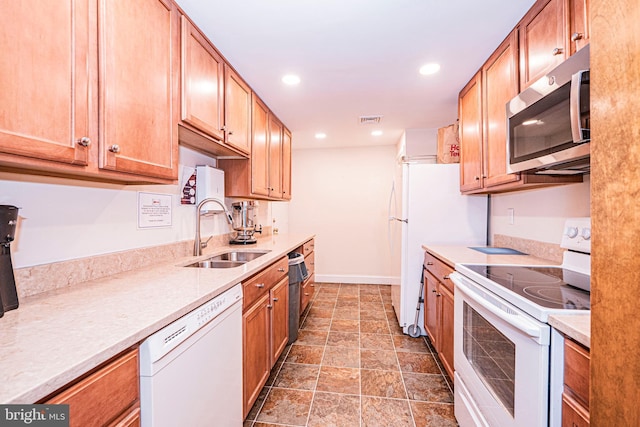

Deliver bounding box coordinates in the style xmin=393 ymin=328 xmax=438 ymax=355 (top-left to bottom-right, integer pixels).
xmin=507 ymin=45 xmax=591 ymax=175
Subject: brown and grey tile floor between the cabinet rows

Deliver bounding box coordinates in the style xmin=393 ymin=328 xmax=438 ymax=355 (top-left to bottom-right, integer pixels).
xmin=244 ymin=283 xmax=457 ymax=427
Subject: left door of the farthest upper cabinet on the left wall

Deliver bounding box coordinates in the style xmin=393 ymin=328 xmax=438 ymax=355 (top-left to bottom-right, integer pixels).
xmin=251 ymin=95 xmax=269 ymax=196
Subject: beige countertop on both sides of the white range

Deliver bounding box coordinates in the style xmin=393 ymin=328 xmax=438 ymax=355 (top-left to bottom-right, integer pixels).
xmin=422 ymin=245 xmax=591 ymax=348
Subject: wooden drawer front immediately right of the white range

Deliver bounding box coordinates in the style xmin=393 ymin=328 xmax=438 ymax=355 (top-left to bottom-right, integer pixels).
xmin=564 ymin=338 xmax=590 ymax=409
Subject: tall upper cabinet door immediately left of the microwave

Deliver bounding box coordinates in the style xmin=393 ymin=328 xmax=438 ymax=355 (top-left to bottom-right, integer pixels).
xmin=482 ymin=31 xmax=520 ymax=187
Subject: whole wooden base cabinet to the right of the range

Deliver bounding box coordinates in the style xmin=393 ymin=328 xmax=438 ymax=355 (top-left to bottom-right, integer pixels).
xmin=562 ymin=337 xmax=590 ymax=427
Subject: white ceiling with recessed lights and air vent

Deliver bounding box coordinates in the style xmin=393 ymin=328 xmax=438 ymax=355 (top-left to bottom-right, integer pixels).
xmin=178 ymin=0 xmax=534 ymax=149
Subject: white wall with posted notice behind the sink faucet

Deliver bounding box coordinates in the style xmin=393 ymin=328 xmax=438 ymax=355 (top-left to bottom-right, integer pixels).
xmin=0 ymin=147 xmax=272 ymax=268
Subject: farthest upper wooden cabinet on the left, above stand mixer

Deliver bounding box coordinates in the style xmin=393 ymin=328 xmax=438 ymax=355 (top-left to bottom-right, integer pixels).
xmin=218 ymin=93 xmax=291 ymax=200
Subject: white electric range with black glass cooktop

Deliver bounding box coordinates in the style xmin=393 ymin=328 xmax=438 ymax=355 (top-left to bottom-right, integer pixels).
xmin=451 ymin=218 xmax=591 ymax=427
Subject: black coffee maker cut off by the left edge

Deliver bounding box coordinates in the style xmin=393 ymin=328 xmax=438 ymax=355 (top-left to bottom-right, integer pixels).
xmin=0 ymin=205 xmax=18 ymax=317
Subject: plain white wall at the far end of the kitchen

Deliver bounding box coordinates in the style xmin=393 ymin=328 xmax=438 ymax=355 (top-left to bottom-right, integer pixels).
xmin=289 ymin=146 xmax=396 ymax=283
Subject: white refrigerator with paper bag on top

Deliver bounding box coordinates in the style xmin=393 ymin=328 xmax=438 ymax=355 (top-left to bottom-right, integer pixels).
xmin=388 ymin=160 xmax=487 ymax=336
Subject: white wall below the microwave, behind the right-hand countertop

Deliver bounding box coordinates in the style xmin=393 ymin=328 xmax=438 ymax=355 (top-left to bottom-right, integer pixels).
xmin=490 ymin=175 xmax=591 ymax=244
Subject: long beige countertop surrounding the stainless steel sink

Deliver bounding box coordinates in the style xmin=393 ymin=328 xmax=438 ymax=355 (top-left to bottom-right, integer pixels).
xmin=0 ymin=234 xmax=314 ymax=403
